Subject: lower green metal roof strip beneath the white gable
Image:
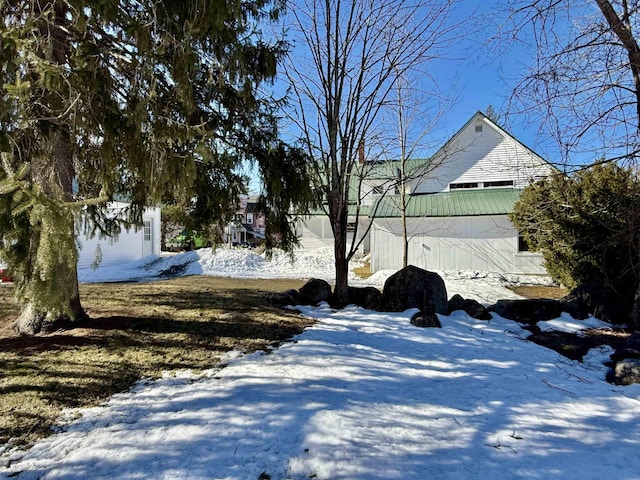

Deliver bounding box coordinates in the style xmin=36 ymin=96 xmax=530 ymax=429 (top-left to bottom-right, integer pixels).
xmin=371 ymin=188 xmax=521 ymax=218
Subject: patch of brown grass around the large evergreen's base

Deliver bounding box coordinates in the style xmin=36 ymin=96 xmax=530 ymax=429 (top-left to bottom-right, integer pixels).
xmin=0 ymin=276 xmax=311 ymax=445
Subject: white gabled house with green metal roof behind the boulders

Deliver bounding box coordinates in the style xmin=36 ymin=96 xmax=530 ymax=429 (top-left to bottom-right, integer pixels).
xmin=301 ymin=112 xmax=554 ymax=274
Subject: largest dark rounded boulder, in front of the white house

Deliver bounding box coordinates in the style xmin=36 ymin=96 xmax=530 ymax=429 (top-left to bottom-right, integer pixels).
xmin=383 ymin=265 xmax=447 ymax=315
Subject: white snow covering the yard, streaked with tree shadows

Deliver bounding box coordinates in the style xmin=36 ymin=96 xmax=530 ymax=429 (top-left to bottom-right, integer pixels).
xmin=0 ymin=250 xmax=640 ymax=480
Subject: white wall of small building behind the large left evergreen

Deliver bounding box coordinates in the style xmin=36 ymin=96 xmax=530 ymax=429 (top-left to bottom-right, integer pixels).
xmin=77 ymin=203 xmax=161 ymax=269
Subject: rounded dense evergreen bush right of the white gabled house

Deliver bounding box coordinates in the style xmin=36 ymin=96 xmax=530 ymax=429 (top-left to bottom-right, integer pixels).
xmin=511 ymin=163 xmax=640 ymax=299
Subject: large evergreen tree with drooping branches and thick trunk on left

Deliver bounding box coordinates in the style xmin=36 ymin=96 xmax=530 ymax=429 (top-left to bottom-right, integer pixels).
xmin=0 ymin=0 xmax=309 ymax=333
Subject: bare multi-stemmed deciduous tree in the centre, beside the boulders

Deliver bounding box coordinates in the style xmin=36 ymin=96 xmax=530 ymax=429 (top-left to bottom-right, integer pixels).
xmin=288 ymin=0 xmax=454 ymax=302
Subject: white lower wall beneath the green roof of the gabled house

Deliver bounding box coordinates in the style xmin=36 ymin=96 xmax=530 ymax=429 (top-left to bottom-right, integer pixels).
xmin=371 ymin=215 xmax=546 ymax=274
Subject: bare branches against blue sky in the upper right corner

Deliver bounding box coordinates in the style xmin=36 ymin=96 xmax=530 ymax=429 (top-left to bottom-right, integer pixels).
xmin=505 ymin=0 xmax=640 ymax=168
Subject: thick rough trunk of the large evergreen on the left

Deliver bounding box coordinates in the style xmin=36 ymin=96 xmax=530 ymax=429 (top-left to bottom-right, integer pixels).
xmin=15 ymin=2 xmax=86 ymax=335
